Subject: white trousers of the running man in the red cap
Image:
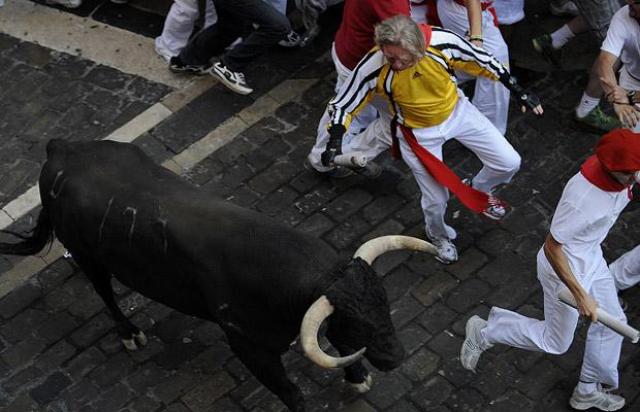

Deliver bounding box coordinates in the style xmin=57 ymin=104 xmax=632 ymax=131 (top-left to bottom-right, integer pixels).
xmin=481 ymin=250 xmax=627 ymax=388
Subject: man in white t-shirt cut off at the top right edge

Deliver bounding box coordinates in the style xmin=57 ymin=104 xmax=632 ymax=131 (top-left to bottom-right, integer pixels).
xmin=595 ymin=0 xmax=640 ymax=131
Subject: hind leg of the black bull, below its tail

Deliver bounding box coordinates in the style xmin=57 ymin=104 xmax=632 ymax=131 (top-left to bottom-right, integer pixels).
xmin=73 ymin=253 xmax=147 ymax=350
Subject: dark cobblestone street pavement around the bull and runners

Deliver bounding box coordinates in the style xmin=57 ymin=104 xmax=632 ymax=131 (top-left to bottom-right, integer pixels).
xmin=0 ymin=2 xmax=640 ymax=412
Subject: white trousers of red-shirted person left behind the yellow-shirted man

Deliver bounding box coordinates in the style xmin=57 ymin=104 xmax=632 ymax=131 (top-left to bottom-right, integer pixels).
xmin=307 ymin=44 xmax=391 ymax=172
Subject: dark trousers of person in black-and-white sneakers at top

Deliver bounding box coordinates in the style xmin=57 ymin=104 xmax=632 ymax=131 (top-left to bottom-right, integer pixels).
xmin=180 ymin=0 xmax=291 ymax=72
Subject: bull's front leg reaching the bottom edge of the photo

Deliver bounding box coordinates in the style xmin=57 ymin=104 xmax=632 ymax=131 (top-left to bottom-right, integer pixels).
xmin=227 ymin=331 xmax=305 ymax=412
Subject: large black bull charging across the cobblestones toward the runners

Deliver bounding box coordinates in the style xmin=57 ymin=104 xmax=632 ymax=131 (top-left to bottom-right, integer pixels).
xmin=0 ymin=140 xmax=436 ymax=411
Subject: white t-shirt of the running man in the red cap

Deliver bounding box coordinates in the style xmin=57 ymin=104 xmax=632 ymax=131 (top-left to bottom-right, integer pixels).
xmin=549 ymin=172 xmax=630 ymax=279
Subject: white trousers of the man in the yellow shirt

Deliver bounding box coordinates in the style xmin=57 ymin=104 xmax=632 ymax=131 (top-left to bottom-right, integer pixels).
xmin=398 ymin=90 xmax=520 ymax=239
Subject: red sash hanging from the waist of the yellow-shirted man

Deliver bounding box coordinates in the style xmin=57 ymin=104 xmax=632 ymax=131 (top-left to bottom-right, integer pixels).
xmin=392 ymin=125 xmax=506 ymax=213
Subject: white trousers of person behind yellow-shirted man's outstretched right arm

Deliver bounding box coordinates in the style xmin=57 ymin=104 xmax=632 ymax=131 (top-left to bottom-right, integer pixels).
xmin=438 ymin=0 xmax=510 ymax=135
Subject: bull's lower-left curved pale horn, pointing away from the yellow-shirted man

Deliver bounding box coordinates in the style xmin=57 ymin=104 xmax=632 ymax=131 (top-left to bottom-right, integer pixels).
xmin=300 ymin=295 xmax=367 ymax=368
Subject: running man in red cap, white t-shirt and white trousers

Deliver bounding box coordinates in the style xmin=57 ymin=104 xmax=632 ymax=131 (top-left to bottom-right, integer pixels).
xmin=460 ymin=129 xmax=640 ymax=411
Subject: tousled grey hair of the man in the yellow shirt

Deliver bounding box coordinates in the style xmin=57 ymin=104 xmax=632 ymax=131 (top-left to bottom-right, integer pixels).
xmin=374 ymin=14 xmax=426 ymax=59
